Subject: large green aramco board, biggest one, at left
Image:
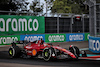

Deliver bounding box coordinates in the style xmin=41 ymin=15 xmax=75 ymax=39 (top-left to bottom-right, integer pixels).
xmin=0 ymin=15 xmax=45 ymax=35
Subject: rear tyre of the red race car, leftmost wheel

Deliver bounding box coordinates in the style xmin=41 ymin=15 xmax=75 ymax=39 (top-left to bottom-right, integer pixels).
xmin=8 ymin=46 xmax=21 ymax=58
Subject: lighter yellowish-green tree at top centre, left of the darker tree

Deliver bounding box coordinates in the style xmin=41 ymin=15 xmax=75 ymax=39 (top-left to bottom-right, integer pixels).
xmin=51 ymin=0 xmax=71 ymax=13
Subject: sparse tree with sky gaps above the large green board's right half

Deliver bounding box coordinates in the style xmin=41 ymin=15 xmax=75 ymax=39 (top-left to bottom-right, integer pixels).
xmin=30 ymin=1 xmax=44 ymax=15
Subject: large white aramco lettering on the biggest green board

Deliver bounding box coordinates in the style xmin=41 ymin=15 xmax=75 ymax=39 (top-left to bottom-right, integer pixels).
xmin=0 ymin=18 xmax=39 ymax=32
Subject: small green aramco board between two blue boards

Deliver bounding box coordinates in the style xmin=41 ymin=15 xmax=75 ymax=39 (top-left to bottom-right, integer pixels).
xmin=45 ymin=34 xmax=66 ymax=42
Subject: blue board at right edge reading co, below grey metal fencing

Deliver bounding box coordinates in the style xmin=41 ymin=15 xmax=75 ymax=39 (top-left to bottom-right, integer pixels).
xmin=89 ymin=36 xmax=100 ymax=53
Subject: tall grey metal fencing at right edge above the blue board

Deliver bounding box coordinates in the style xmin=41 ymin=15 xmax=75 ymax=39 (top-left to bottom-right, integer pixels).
xmin=86 ymin=0 xmax=100 ymax=37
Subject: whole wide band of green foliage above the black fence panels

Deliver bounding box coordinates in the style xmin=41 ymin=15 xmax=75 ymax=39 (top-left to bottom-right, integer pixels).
xmin=51 ymin=0 xmax=88 ymax=14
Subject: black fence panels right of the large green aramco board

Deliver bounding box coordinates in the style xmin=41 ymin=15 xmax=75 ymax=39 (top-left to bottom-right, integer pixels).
xmin=45 ymin=17 xmax=89 ymax=33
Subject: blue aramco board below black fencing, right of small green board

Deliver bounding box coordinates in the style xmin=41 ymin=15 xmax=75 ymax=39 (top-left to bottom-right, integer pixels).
xmin=66 ymin=33 xmax=84 ymax=42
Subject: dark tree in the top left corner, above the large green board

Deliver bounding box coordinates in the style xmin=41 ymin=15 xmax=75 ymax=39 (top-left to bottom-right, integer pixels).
xmin=0 ymin=0 xmax=28 ymax=11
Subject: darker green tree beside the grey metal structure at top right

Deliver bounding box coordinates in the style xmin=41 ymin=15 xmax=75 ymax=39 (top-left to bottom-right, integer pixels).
xmin=68 ymin=0 xmax=89 ymax=14
